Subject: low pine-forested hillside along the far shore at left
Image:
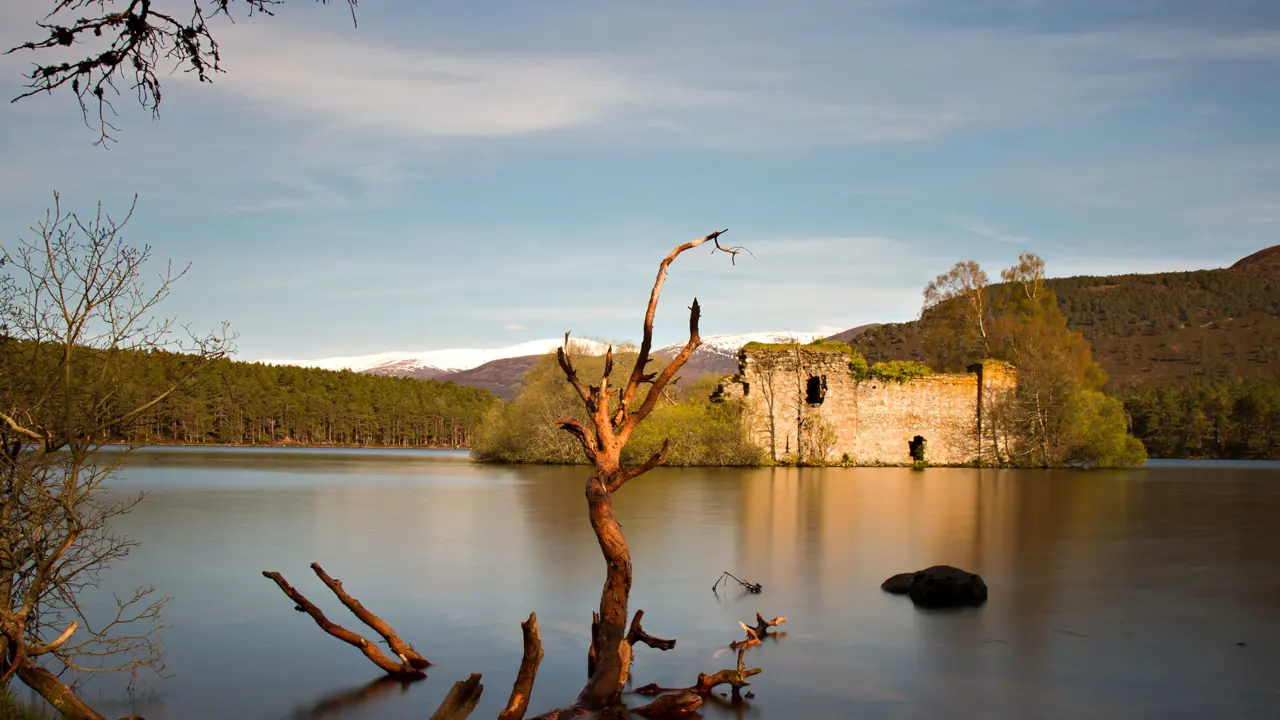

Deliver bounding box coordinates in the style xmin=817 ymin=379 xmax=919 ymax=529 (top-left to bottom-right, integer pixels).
xmin=0 ymin=340 xmax=497 ymax=447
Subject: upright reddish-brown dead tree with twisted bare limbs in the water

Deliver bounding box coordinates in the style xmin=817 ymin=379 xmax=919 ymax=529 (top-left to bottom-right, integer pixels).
xmin=557 ymin=231 xmax=741 ymax=710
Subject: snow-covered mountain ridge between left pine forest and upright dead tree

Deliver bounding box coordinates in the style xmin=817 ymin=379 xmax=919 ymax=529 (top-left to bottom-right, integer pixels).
xmin=262 ymin=338 xmax=605 ymax=378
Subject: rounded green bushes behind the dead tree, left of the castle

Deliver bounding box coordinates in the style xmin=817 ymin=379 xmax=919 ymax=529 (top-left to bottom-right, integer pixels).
xmin=471 ymin=352 xmax=763 ymax=465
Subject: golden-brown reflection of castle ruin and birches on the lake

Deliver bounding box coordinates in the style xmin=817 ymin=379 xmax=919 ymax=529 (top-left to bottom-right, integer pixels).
xmin=737 ymin=468 xmax=1129 ymax=674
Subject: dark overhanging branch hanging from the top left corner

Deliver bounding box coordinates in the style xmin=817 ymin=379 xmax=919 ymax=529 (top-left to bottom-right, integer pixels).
xmin=8 ymin=0 xmax=358 ymax=143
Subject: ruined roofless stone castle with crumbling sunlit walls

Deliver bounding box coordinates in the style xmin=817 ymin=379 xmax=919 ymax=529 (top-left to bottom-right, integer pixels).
xmin=718 ymin=345 xmax=1016 ymax=465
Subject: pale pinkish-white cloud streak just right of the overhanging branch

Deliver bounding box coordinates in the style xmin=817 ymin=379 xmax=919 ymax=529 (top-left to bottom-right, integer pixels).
xmin=208 ymin=27 xmax=655 ymax=137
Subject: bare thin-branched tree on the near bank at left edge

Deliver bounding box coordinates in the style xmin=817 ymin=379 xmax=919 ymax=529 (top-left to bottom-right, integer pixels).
xmin=0 ymin=195 xmax=229 ymax=720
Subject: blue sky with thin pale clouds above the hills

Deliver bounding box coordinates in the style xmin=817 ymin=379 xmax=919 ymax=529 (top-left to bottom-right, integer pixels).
xmin=0 ymin=0 xmax=1280 ymax=360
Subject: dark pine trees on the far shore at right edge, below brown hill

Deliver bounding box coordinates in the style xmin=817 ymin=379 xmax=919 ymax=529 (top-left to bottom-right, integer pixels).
xmin=1121 ymin=378 xmax=1280 ymax=460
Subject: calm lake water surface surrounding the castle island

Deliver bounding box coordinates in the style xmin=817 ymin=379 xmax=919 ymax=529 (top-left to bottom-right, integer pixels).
xmin=37 ymin=448 xmax=1280 ymax=720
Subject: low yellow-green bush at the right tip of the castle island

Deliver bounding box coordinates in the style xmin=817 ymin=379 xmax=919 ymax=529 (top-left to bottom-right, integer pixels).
xmin=1065 ymin=389 xmax=1147 ymax=468
